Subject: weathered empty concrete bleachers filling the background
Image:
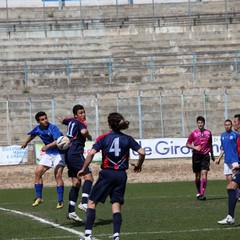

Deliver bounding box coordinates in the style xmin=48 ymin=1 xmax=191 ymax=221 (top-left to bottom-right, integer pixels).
xmin=0 ymin=1 xmax=240 ymax=140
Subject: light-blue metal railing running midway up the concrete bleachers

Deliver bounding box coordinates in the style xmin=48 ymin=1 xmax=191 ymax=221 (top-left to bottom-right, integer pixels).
xmin=0 ymin=49 xmax=239 ymax=87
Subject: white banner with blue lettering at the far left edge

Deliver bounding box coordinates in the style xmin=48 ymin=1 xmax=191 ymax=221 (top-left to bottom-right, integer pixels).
xmin=0 ymin=145 xmax=28 ymax=165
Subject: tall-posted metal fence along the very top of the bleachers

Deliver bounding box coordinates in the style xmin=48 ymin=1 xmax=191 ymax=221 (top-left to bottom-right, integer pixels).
xmin=0 ymin=0 xmax=240 ymax=35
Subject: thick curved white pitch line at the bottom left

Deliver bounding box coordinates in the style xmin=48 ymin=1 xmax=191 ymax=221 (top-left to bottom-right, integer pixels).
xmin=0 ymin=207 xmax=97 ymax=240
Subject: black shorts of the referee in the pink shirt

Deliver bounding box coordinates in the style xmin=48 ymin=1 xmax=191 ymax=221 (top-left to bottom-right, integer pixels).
xmin=192 ymin=153 xmax=210 ymax=173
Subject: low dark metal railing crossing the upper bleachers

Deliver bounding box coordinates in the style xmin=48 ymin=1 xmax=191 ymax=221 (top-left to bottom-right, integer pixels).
xmin=0 ymin=12 xmax=240 ymax=33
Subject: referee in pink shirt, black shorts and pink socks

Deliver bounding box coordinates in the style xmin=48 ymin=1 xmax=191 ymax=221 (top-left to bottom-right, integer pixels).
xmin=186 ymin=116 xmax=215 ymax=201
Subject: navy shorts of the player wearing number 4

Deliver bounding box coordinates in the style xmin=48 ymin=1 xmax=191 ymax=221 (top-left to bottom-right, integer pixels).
xmin=89 ymin=169 xmax=127 ymax=205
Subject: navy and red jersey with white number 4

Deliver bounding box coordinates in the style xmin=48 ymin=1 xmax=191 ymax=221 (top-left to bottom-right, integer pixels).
xmin=92 ymin=131 xmax=141 ymax=170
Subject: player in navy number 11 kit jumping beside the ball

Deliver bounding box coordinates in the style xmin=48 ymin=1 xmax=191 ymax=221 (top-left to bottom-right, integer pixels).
xmin=58 ymin=104 xmax=93 ymax=222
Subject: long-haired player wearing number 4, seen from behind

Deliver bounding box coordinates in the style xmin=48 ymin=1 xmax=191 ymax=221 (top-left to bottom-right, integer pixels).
xmin=78 ymin=113 xmax=145 ymax=240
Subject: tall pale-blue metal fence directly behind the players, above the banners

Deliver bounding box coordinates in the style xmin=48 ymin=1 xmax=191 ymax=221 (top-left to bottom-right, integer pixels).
xmin=0 ymin=91 xmax=240 ymax=145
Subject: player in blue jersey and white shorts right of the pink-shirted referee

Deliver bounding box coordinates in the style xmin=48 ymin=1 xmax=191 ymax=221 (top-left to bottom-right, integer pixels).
xmin=216 ymin=119 xmax=240 ymax=182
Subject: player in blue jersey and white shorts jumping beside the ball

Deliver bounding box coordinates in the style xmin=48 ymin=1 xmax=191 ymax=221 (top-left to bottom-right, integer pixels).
xmin=22 ymin=112 xmax=65 ymax=209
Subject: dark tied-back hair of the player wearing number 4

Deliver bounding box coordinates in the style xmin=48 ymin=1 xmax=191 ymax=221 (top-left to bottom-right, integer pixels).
xmin=108 ymin=112 xmax=130 ymax=131
